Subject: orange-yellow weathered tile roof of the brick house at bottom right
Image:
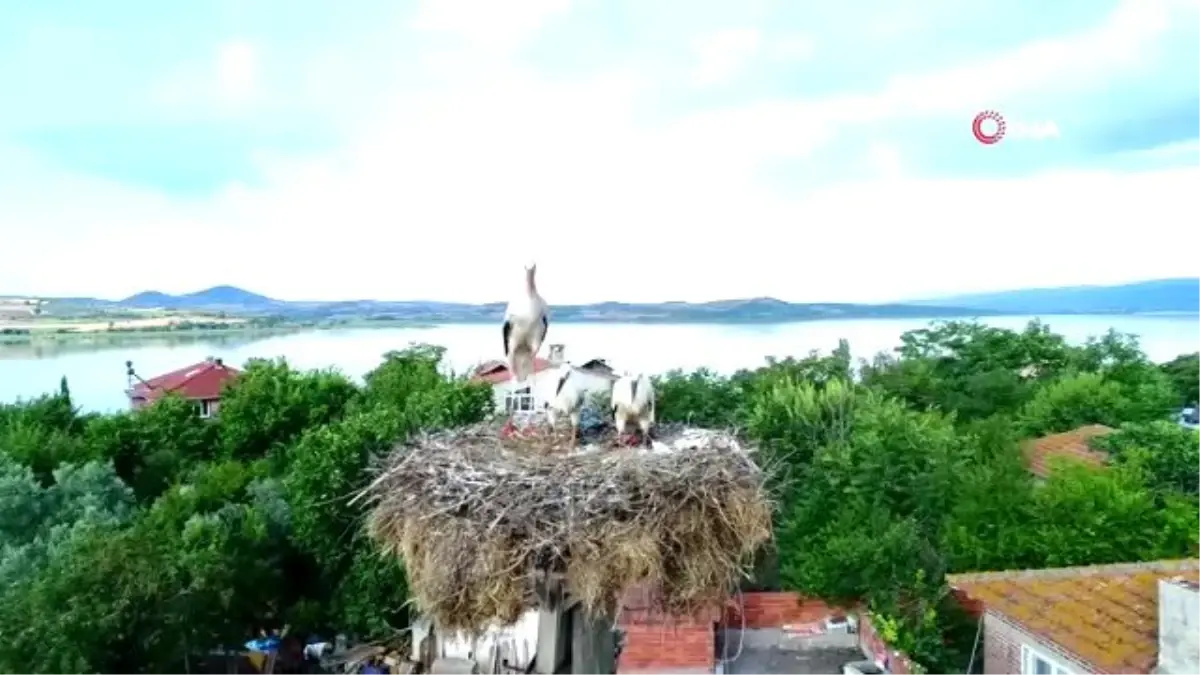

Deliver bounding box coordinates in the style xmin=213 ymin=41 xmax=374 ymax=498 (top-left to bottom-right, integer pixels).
xmin=947 ymin=558 xmax=1200 ymax=673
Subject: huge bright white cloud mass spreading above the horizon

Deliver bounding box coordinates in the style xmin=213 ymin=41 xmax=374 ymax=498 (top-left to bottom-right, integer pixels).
xmin=0 ymin=0 xmax=1200 ymax=301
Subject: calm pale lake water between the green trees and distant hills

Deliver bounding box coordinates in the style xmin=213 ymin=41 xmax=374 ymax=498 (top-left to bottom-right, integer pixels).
xmin=7 ymin=316 xmax=1200 ymax=411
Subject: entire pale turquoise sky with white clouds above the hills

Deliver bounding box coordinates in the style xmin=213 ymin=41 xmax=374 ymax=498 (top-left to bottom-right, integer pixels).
xmin=0 ymin=0 xmax=1200 ymax=304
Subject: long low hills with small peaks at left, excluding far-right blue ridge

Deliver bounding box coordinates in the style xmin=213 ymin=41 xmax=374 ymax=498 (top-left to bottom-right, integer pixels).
xmin=35 ymin=286 xmax=995 ymax=323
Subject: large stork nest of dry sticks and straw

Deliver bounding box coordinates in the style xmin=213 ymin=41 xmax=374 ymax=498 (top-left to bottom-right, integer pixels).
xmin=360 ymin=424 xmax=772 ymax=632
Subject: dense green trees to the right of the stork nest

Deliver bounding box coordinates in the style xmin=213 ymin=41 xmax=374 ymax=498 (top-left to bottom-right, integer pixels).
xmin=659 ymin=322 xmax=1200 ymax=673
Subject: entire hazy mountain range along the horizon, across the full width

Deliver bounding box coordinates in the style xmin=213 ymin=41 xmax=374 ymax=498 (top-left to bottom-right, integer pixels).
xmin=25 ymin=279 xmax=1200 ymax=323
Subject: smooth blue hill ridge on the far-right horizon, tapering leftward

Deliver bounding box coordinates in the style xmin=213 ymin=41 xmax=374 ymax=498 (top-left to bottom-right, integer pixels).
xmin=911 ymin=279 xmax=1200 ymax=315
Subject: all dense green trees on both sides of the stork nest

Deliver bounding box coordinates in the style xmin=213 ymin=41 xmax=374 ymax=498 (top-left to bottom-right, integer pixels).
xmin=0 ymin=322 xmax=1200 ymax=675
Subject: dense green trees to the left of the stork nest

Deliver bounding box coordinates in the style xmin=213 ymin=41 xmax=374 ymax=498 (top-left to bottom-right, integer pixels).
xmin=0 ymin=347 xmax=492 ymax=675
